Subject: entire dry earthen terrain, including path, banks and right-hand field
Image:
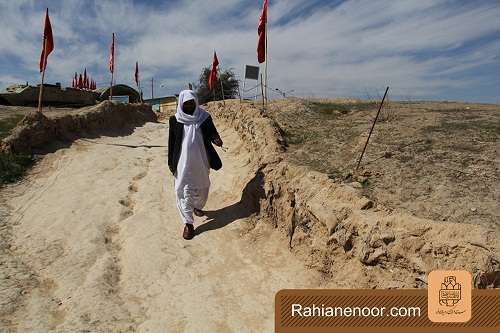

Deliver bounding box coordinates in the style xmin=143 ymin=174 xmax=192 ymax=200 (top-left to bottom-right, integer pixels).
xmin=0 ymin=98 xmax=500 ymax=332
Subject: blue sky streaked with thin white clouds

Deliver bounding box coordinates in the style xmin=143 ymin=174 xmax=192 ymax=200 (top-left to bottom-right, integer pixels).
xmin=0 ymin=0 xmax=500 ymax=103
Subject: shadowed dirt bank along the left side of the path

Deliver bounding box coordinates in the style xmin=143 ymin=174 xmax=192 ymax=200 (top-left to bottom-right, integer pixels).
xmin=1 ymin=101 xmax=156 ymax=153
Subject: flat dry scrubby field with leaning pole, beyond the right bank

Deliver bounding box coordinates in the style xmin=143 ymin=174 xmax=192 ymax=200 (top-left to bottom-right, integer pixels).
xmin=264 ymin=99 xmax=500 ymax=229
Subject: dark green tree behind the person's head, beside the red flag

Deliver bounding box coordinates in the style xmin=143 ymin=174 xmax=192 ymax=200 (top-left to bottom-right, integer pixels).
xmin=195 ymin=67 xmax=238 ymax=104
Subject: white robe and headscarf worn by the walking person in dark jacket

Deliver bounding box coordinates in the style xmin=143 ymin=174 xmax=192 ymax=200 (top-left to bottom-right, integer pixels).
xmin=174 ymin=90 xmax=210 ymax=224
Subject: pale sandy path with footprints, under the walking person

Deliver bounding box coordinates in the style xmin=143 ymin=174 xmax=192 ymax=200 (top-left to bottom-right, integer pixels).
xmin=0 ymin=118 xmax=322 ymax=332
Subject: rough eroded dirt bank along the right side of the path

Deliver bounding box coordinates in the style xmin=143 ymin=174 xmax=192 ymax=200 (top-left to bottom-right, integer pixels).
xmin=207 ymin=101 xmax=500 ymax=288
